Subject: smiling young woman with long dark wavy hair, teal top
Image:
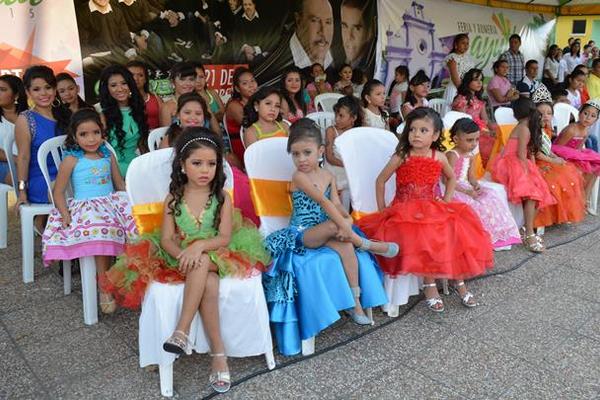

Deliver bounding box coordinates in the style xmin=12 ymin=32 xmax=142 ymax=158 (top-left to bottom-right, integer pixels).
xmin=100 ymin=65 xmax=148 ymax=176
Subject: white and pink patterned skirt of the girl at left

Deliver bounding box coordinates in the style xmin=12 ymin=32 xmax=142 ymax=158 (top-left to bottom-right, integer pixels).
xmin=42 ymin=192 xmax=137 ymax=265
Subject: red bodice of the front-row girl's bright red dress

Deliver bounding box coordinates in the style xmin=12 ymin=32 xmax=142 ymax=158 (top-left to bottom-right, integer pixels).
xmin=394 ymin=157 xmax=442 ymax=202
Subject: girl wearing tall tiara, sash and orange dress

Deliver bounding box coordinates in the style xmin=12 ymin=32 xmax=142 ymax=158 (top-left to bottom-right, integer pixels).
xmin=531 ymin=86 xmax=585 ymax=228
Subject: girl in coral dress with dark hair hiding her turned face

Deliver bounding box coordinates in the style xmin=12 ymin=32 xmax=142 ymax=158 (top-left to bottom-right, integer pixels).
xmin=492 ymin=97 xmax=556 ymax=253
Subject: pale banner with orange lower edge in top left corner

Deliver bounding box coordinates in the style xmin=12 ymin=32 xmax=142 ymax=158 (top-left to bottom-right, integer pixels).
xmin=0 ymin=0 xmax=83 ymax=88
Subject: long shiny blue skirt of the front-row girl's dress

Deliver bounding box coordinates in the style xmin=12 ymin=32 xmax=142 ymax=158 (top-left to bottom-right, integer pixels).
xmin=263 ymin=227 xmax=387 ymax=356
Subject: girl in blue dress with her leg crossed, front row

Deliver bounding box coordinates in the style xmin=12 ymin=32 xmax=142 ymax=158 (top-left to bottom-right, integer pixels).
xmin=265 ymin=118 xmax=398 ymax=355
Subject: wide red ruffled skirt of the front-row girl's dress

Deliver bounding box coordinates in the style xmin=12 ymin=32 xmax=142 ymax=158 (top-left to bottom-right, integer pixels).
xmin=357 ymin=200 xmax=494 ymax=279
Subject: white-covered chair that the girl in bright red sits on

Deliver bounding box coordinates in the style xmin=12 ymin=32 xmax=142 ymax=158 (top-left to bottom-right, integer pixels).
xmin=335 ymin=127 xmax=422 ymax=317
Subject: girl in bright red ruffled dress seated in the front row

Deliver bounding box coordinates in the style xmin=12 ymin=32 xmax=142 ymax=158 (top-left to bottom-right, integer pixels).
xmin=357 ymin=107 xmax=494 ymax=312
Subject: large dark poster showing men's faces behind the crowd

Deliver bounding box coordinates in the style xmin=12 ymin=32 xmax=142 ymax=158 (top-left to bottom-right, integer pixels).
xmin=74 ymin=0 xmax=377 ymax=97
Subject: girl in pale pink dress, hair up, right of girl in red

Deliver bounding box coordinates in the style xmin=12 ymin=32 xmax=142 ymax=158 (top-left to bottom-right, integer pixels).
xmin=446 ymin=118 xmax=521 ymax=250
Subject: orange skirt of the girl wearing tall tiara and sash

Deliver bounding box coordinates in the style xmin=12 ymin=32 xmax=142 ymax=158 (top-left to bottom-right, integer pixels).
xmin=534 ymin=160 xmax=585 ymax=227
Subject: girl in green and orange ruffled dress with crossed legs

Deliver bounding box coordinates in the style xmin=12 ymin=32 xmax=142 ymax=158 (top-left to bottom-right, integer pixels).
xmin=101 ymin=127 xmax=270 ymax=392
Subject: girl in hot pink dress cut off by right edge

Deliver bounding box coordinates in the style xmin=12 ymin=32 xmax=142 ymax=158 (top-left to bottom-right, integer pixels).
xmin=552 ymin=100 xmax=600 ymax=215
